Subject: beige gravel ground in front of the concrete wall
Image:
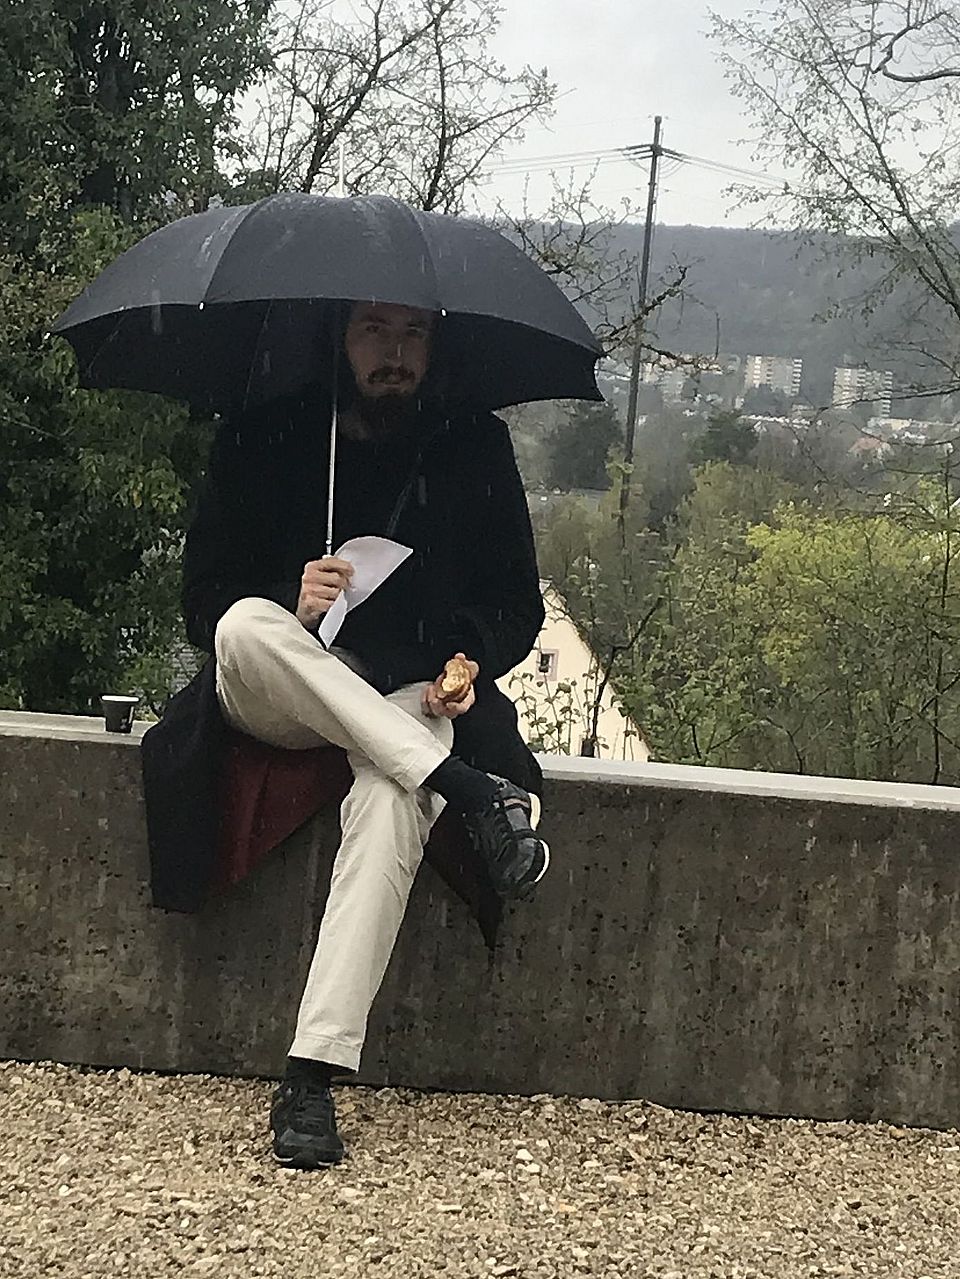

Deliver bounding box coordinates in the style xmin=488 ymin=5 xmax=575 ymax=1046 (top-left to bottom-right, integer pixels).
xmin=0 ymin=1063 xmax=960 ymax=1279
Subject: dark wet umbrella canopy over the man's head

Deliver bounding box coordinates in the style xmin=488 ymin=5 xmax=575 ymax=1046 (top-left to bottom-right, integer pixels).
xmin=52 ymin=194 xmax=601 ymax=412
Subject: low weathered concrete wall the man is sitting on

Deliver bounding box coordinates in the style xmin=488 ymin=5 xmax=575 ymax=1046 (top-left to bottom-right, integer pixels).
xmin=0 ymin=714 xmax=960 ymax=1127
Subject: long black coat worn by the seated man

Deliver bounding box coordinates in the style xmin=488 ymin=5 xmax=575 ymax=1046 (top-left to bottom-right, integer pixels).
xmin=142 ymin=395 xmax=543 ymax=931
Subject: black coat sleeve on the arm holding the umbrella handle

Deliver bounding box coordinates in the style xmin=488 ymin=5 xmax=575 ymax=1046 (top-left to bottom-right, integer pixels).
xmin=182 ymin=423 xmax=299 ymax=652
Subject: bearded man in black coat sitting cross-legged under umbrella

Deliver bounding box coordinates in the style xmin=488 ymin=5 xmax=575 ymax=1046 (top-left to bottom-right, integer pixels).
xmin=177 ymin=303 xmax=548 ymax=1168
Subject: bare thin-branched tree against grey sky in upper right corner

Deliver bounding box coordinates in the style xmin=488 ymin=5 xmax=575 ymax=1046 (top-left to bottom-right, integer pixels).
xmin=713 ymin=0 xmax=960 ymax=393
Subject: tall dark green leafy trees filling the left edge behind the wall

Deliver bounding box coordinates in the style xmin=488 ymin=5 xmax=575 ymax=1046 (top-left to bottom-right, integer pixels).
xmin=0 ymin=0 xmax=266 ymax=712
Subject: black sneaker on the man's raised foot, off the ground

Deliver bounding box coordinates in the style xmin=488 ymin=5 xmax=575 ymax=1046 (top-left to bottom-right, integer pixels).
xmin=464 ymin=775 xmax=550 ymax=898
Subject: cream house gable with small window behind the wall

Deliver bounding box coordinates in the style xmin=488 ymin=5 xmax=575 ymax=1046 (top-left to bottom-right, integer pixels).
xmin=497 ymin=582 xmax=649 ymax=762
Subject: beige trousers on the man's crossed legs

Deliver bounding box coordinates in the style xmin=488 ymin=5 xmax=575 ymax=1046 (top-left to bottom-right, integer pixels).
xmin=216 ymin=599 xmax=454 ymax=1071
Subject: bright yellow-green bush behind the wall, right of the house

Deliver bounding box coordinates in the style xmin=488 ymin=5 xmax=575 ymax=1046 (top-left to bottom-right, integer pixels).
xmin=748 ymin=510 xmax=945 ymax=779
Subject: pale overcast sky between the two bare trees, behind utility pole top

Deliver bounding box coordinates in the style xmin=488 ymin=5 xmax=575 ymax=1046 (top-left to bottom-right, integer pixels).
xmin=484 ymin=0 xmax=772 ymax=226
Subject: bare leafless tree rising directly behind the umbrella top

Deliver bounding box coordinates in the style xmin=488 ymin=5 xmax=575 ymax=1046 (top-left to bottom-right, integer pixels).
xmin=239 ymin=0 xmax=555 ymax=212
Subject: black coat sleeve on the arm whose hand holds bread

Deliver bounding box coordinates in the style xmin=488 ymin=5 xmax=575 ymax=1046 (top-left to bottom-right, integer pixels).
xmin=446 ymin=417 xmax=543 ymax=680
